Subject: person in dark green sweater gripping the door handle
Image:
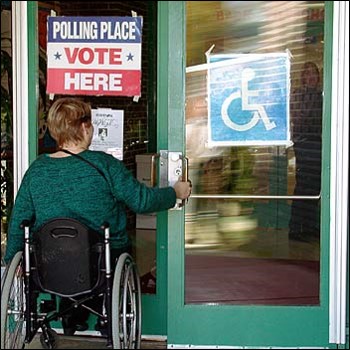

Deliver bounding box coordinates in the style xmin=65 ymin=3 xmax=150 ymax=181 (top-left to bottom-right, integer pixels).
xmin=1 ymin=98 xmax=191 ymax=348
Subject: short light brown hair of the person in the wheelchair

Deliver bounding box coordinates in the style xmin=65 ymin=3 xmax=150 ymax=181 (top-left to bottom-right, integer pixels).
xmin=47 ymin=97 xmax=91 ymax=147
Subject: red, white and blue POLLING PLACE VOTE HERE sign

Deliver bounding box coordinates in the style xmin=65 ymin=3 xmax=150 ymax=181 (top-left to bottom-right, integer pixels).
xmin=47 ymin=17 xmax=142 ymax=96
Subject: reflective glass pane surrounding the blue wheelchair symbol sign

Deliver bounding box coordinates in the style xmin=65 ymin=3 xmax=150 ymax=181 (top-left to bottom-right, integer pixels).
xmin=185 ymin=1 xmax=324 ymax=305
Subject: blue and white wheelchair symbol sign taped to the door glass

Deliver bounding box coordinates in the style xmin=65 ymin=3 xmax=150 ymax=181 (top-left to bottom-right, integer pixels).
xmin=208 ymin=53 xmax=291 ymax=147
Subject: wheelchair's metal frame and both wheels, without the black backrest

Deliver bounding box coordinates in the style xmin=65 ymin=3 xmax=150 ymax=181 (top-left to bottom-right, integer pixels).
xmin=1 ymin=219 xmax=141 ymax=349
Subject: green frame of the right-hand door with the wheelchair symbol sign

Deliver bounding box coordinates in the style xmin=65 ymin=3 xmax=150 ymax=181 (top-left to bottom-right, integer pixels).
xmin=165 ymin=1 xmax=335 ymax=347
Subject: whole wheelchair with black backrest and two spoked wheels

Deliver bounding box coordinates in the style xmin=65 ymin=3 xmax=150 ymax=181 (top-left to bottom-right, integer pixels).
xmin=1 ymin=218 xmax=141 ymax=349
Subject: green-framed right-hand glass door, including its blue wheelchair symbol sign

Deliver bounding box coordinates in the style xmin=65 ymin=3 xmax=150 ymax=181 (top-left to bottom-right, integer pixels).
xmin=164 ymin=1 xmax=331 ymax=347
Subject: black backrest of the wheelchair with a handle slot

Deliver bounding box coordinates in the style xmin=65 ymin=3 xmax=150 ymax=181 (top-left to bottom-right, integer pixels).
xmin=31 ymin=218 xmax=104 ymax=297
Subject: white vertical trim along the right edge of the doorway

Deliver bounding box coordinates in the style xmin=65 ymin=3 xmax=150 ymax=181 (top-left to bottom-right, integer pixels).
xmin=329 ymin=1 xmax=349 ymax=344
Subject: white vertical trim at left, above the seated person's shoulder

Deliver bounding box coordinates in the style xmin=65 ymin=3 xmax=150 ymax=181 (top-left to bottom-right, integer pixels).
xmin=12 ymin=1 xmax=29 ymax=196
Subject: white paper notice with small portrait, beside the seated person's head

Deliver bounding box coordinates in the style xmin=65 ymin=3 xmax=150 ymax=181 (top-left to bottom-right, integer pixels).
xmin=90 ymin=109 xmax=124 ymax=160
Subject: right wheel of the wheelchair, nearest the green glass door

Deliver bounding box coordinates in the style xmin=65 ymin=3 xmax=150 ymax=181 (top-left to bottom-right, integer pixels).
xmin=112 ymin=253 xmax=141 ymax=349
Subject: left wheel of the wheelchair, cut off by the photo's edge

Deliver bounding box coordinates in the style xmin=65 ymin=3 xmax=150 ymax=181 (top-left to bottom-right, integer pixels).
xmin=1 ymin=252 xmax=26 ymax=349
